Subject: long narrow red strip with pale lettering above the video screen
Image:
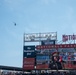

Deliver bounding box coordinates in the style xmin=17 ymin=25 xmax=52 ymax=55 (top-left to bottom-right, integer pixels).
xmin=36 ymin=44 xmax=76 ymax=50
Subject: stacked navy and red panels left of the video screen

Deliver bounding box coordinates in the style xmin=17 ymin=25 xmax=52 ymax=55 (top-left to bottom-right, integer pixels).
xmin=23 ymin=46 xmax=35 ymax=70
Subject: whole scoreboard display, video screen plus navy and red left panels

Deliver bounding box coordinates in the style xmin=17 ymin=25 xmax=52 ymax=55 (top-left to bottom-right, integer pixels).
xmin=23 ymin=46 xmax=76 ymax=70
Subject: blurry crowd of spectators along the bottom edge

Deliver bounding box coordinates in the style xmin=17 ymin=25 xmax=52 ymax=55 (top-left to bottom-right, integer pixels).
xmin=1 ymin=72 xmax=76 ymax=75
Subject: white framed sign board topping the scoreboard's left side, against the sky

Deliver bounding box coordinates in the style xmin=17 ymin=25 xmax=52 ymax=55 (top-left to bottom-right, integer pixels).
xmin=24 ymin=32 xmax=57 ymax=42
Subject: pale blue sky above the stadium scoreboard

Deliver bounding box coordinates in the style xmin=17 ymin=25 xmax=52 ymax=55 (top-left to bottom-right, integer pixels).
xmin=0 ymin=0 xmax=76 ymax=67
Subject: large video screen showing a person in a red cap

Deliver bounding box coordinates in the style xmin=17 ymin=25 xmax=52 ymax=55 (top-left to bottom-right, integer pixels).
xmin=36 ymin=48 xmax=76 ymax=69
